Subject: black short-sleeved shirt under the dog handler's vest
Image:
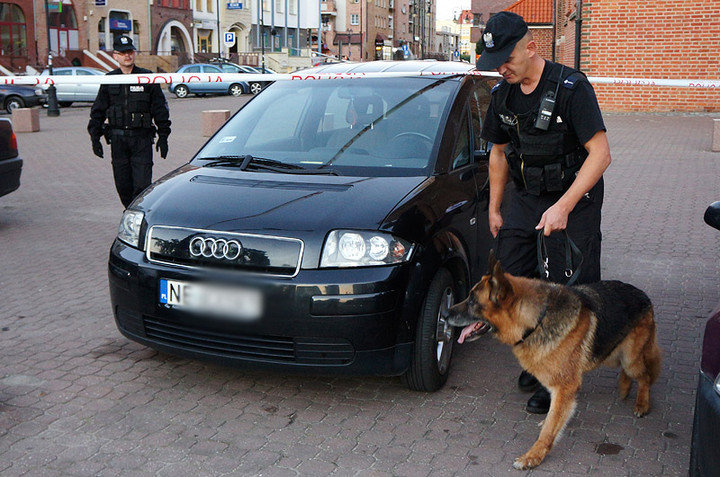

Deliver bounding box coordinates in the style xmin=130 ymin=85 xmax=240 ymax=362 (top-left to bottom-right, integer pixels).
xmin=482 ymin=60 xmax=606 ymax=144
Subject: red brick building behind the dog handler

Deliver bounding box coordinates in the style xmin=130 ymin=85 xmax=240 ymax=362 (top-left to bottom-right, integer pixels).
xmin=472 ymin=0 xmax=720 ymax=112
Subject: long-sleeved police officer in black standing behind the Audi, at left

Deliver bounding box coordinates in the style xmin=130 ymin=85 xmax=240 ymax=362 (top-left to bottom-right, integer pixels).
xmin=87 ymin=35 xmax=170 ymax=207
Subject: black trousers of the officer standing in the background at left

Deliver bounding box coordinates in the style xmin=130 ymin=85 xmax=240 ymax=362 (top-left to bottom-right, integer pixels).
xmin=111 ymin=133 xmax=153 ymax=208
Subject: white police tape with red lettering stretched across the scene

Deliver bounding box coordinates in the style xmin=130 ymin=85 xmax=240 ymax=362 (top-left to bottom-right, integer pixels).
xmin=0 ymin=70 xmax=720 ymax=90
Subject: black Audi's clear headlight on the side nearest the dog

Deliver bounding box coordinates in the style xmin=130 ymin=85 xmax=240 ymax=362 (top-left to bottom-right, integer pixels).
xmin=320 ymin=230 xmax=413 ymax=268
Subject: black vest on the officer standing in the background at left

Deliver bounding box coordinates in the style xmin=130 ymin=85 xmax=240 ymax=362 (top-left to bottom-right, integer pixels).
xmin=107 ymin=84 xmax=154 ymax=129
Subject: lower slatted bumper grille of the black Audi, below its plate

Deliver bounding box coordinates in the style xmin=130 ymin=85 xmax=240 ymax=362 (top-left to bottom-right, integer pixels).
xmin=143 ymin=316 xmax=355 ymax=366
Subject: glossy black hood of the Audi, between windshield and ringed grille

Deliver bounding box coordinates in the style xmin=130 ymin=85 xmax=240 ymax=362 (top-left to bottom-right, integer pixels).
xmin=136 ymin=165 xmax=427 ymax=238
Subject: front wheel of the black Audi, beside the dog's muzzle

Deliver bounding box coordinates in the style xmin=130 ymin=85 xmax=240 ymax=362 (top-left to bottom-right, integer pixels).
xmin=403 ymin=268 xmax=457 ymax=392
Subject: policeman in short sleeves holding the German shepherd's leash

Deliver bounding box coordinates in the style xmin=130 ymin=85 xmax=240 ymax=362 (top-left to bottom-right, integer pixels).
xmin=477 ymin=12 xmax=611 ymax=414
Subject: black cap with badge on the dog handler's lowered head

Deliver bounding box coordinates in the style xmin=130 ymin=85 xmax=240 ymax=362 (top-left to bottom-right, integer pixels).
xmin=477 ymin=12 xmax=528 ymax=71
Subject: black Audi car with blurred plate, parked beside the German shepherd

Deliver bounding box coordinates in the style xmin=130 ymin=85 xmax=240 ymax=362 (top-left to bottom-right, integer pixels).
xmin=109 ymin=61 xmax=492 ymax=391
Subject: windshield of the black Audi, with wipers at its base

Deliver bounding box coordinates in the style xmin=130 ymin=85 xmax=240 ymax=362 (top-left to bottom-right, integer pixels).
xmin=193 ymin=78 xmax=458 ymax=176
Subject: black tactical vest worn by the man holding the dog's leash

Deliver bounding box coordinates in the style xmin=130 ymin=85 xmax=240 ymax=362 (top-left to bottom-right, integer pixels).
xmin=492 ymin=62 xmax=588 ymax=195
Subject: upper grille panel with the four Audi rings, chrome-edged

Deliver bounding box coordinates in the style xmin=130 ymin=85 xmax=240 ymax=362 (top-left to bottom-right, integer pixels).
xmin=147 ymin=225 xmax=303 ymax=277
